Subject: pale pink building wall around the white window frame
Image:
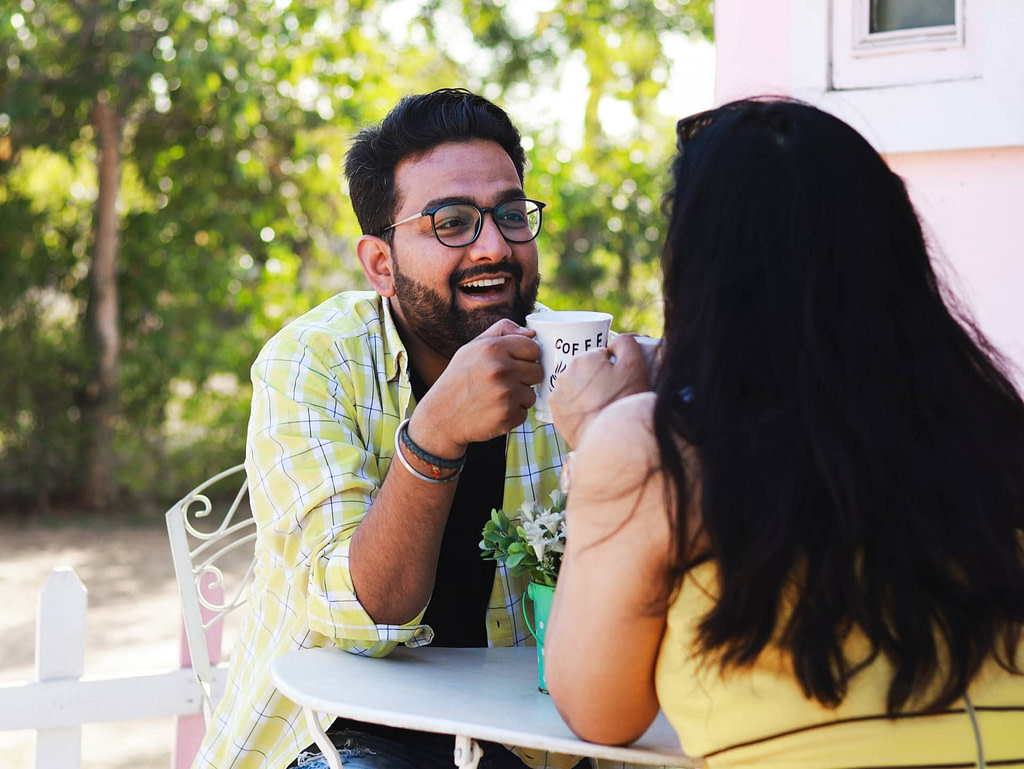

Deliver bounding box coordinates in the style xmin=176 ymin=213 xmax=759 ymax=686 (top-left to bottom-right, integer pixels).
xmin=715 ymin=0 xmax=1024 ymax=388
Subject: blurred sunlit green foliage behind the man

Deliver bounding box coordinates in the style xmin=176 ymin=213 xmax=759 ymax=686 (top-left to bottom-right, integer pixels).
xmin=0 ymin=0 xmax=712 ymax=518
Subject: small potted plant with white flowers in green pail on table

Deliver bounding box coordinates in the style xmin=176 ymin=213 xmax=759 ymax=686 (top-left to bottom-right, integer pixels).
xmin=480 ymin=489 xmax=565 ymax=693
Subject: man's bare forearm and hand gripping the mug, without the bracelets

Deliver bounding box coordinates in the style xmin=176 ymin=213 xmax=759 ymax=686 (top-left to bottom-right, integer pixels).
xmin=349 ymin=321 xmax=542 ymax=625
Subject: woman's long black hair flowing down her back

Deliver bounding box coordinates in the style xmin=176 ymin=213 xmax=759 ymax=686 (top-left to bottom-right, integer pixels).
xmin=654 ymin=99 xmax=1024 ymax=714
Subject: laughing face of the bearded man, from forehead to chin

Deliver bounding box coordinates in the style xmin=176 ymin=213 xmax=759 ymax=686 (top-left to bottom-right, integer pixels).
xmin=391 ymin=139 xmax=540 ymax=358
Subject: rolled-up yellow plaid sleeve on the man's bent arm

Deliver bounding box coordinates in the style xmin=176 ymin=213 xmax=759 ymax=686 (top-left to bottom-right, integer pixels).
xmin=246 ymin=327 xmax=432 ymax=656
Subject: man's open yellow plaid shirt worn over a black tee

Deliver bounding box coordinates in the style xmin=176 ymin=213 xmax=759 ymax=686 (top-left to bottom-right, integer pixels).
xmin=195 ymin=292 xmax=575 ymax=769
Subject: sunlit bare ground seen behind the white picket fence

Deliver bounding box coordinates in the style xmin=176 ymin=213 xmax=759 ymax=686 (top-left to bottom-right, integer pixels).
xmin=0 ymin=518 xmax=247 ymax=769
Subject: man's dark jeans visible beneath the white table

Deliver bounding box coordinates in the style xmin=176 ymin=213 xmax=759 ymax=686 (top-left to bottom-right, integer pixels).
xmin=291 ymin=721 xmax=587 ymax=769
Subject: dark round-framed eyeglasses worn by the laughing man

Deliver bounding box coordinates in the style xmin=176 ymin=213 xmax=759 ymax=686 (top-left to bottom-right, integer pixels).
xmin=382 ymin=198 xmax=547 ymax=249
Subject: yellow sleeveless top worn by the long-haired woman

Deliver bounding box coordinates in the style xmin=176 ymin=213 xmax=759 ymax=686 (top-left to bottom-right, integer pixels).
xmin=655 ymin=562 xmax=1024 ymax=769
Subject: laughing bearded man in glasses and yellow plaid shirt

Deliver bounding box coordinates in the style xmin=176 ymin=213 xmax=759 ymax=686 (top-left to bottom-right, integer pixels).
xmin=197 ymin=89 xmax=574 ymax=769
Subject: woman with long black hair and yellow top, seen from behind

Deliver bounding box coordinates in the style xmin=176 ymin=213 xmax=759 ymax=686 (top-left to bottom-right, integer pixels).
xmin=545 ymin=99 xmax=1024 ymax=769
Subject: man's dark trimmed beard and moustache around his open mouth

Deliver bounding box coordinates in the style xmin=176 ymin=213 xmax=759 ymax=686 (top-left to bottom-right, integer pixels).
xmin=391 ymin=249 xmax=541 ymax=358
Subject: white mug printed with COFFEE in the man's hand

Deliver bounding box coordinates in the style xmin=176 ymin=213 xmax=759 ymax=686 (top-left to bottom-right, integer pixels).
xmin=526 ymin=310 xmax=611 ymax=422
